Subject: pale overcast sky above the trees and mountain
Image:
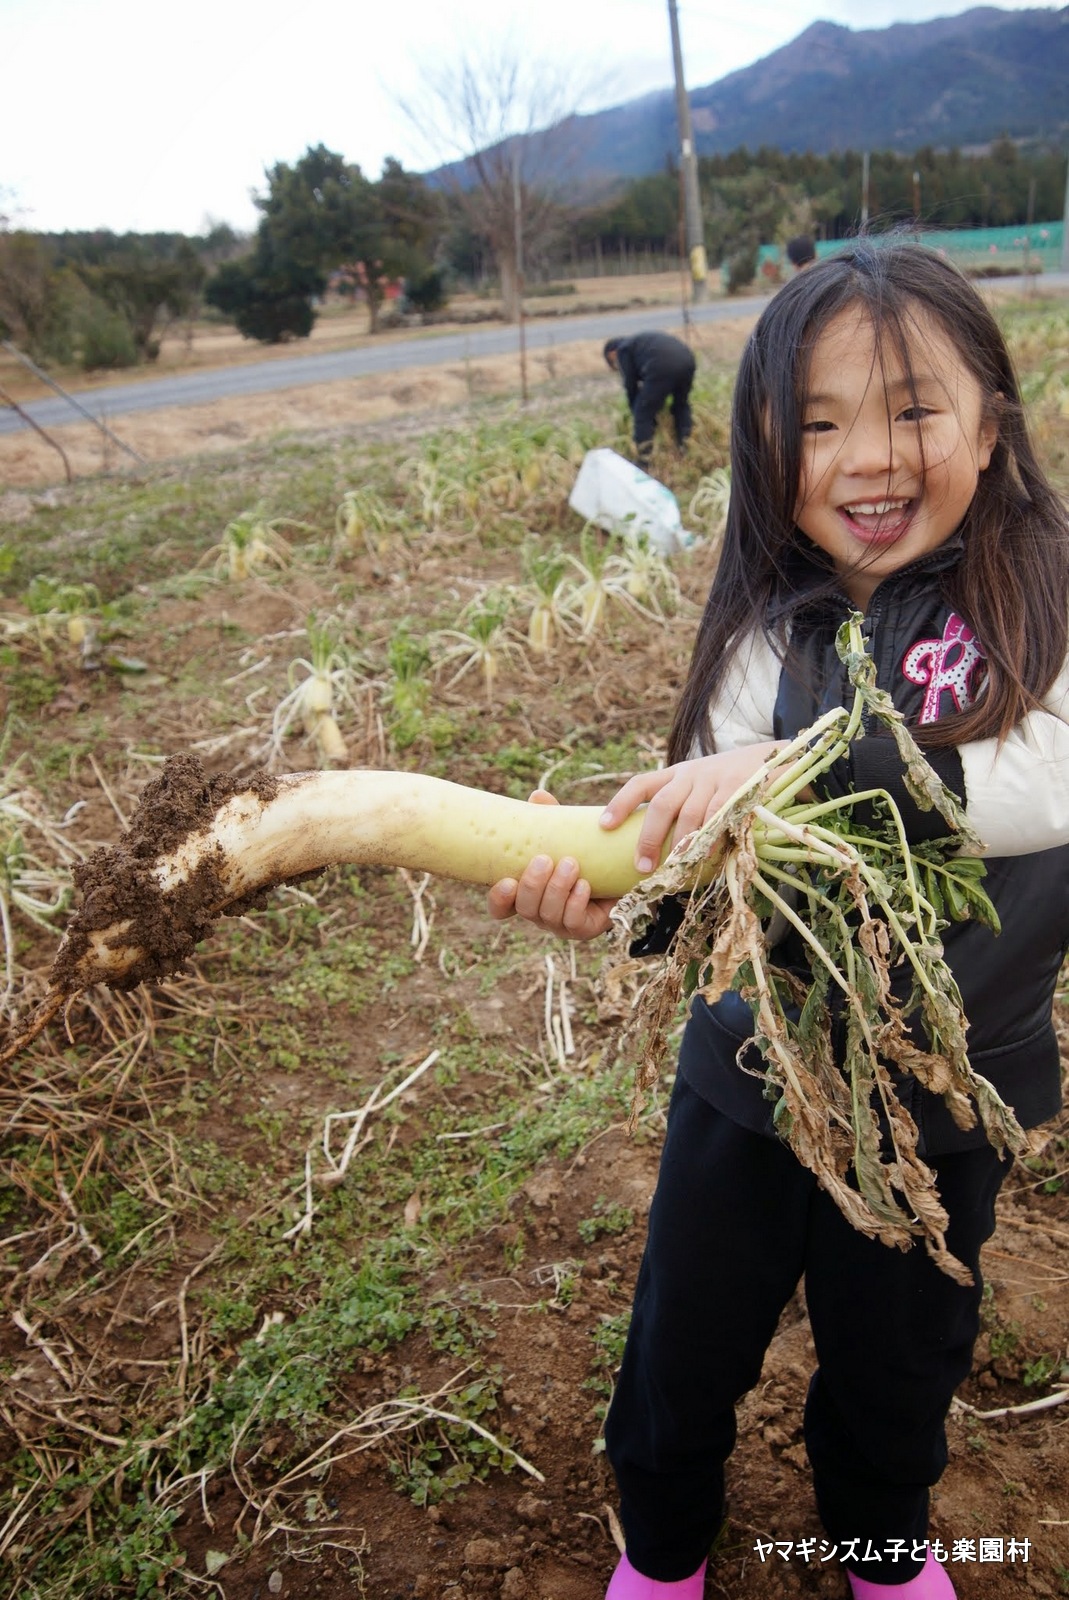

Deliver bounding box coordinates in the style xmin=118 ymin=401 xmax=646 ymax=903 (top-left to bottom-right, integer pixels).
xmin=0 ymin=0 xmax=1056 ymax=234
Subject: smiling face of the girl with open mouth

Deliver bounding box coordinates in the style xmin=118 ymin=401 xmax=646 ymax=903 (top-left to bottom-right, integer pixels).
xmin=794 ymin=307 xmax=999 ymax=610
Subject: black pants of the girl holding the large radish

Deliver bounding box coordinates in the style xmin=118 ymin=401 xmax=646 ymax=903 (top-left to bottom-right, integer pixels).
xmin=605 ymin=1078 xmax=1008 ymax=1584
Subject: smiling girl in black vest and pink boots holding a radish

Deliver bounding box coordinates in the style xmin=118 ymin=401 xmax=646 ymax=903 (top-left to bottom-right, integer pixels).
xmin=490 ymin=242 xmax=1069 ymax=1600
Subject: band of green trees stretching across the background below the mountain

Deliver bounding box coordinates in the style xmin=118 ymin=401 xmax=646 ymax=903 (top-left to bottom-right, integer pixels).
xmin=0 ymin=139 xmax=1066 ymax=368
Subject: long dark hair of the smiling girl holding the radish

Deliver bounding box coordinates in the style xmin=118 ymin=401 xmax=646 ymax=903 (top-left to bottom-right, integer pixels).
xmin=667 ymin=242 xmax=1069 ymax=762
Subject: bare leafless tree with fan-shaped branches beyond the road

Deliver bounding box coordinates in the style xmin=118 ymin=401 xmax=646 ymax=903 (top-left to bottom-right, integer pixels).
xmin=400 ymin=40 xmax=601 ymax=322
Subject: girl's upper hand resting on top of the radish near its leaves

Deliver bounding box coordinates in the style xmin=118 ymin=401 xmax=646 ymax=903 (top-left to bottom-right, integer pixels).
xmin=602 ymin=739 xmax=783 ymax=872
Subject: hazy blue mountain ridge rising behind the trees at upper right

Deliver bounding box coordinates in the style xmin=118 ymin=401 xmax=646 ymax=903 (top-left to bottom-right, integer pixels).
xmin=575 ymin=6 xmax=1069 ymax=178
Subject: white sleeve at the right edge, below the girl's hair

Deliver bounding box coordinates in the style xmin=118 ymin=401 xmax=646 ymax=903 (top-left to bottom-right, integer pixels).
xmin=959 ymin=662 xmax=1069 ymax=856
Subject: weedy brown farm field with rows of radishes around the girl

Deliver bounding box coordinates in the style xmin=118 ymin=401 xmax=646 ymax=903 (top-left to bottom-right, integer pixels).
xmin=0 ymin=291 xmax=1069 ymax=1600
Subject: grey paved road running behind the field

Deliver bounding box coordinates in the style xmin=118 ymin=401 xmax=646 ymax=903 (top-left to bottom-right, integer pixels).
xmin=0 ymin=296 xmax=767 ymax=434
